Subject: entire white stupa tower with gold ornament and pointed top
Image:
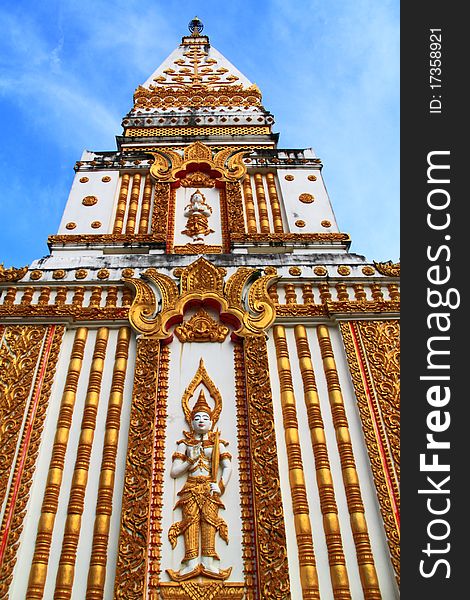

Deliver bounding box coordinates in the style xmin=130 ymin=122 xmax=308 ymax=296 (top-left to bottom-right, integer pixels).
xmin=0 ymin=18 xmax=400 ymax=600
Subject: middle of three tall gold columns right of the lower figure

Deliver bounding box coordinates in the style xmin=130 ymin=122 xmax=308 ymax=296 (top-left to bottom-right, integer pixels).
xmin=294 ymin=325 xmax=351 ymax=600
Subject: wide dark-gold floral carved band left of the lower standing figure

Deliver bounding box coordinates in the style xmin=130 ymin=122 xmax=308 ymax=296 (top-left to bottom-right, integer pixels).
xmin=114 ymin=337 xmax=161 ymax=600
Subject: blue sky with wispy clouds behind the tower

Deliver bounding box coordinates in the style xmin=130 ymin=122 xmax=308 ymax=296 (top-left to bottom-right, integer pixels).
xmin=0 ymin=0 xmax=400 ymax=267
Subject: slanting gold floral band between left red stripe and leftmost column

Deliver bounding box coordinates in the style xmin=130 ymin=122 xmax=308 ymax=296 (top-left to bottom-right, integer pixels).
xmin=0 ymin=326 xmax=64 ymax=600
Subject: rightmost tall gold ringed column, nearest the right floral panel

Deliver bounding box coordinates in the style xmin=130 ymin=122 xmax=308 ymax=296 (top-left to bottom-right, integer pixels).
xmin=317 ymin=325 xmax=382 ymax=600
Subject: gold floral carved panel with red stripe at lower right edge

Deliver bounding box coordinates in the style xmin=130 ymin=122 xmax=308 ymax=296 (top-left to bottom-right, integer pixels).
xmin=340 ymin=320 xmax=400 ymax=581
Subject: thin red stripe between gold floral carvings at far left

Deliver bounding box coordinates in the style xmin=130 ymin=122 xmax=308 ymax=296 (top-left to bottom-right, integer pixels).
xmin=0 ymin=325 xmax=56 ymax=564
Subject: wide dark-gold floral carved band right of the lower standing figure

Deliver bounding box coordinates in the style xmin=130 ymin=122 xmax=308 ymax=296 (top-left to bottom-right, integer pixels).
xmin=244 ymin=336 xmax=291 ymax=600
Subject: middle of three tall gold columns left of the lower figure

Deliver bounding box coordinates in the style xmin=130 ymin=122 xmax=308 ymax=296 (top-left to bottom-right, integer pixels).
xmin=54 ymin=327 xmax=109 ymax=600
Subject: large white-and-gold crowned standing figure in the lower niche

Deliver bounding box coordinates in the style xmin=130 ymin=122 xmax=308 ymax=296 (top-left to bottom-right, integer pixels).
xmin=167 ymin=389 xmax=232 ymax=581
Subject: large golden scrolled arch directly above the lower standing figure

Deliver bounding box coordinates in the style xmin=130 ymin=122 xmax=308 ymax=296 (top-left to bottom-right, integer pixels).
xmin=124 ymin=257 xmax=278 ymax=342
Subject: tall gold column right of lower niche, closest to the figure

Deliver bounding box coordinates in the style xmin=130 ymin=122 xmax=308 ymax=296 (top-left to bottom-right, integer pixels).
xmin=274 ymin=325 xmax=320 ymax=598
